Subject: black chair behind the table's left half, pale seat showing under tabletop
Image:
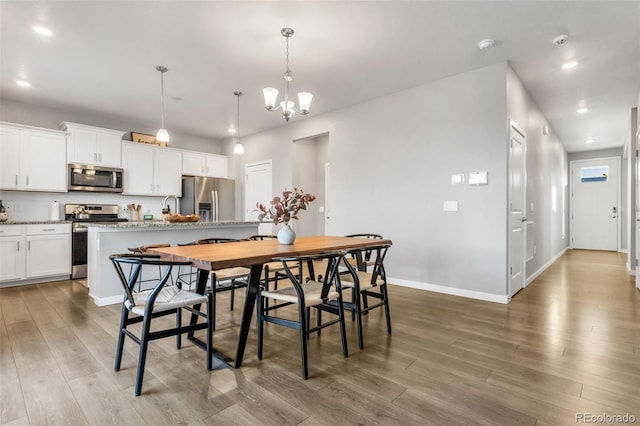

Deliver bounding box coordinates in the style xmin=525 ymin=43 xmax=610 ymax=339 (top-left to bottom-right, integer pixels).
xmin=178 ymin=237 xmax=251 ymax=330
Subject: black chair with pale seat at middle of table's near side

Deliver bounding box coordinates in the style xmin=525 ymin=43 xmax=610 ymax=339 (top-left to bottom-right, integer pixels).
xmin=257 ymin=253 xmax=349 ymax=379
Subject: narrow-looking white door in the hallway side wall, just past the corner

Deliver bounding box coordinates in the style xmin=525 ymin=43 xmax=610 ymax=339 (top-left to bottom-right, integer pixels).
xmin=509 ymin=121 xmax=527 ymax=296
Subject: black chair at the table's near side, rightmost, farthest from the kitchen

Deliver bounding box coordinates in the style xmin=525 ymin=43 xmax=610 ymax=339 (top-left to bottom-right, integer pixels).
xmin=340 ymin=244 xmax=391 ymax=349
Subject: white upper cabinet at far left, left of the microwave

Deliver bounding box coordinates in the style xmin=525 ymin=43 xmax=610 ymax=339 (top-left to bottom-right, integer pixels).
xmin=0 ymin=123 xmax=67 ymax=192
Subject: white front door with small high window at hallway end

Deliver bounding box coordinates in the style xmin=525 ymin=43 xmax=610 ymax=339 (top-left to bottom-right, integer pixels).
xmin=571 ymin=158 xmax=620 ymax=251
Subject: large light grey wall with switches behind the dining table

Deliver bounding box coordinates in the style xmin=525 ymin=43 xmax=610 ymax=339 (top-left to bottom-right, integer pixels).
xmin=234 ymin=63 xmax=507 ymax=298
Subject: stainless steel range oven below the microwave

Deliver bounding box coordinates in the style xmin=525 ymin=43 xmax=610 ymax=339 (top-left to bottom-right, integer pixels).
xmin=64 ymin=204 xmax=127 ymax=279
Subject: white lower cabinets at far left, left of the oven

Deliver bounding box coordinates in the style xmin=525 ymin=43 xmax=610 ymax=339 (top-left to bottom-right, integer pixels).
xmin=0 ymin=224 xmax=71 ymax=284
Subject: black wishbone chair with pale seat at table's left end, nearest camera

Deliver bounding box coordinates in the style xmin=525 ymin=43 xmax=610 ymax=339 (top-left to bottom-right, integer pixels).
xmin=109 ymin=253 xmax=213 ymax=396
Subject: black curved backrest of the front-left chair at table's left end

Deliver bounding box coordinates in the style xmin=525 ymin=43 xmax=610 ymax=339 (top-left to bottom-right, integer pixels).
xmin=109 ymin=253 xmax=191 ymax=307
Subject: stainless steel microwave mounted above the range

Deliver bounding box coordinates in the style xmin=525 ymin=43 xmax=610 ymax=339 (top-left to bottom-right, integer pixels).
xmin=68 ymin=164 xmax=124 ymax=192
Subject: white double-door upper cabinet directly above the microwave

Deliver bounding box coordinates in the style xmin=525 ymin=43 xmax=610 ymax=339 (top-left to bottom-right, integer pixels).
xmin=60 ymin=121 xmax=126 ymax=167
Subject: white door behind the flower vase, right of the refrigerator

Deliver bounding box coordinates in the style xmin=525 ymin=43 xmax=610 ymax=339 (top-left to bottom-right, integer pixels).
xmin=244 ymin=160 xmax=273 ymax=235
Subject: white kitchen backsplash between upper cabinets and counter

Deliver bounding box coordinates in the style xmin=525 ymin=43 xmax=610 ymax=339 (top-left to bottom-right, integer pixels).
xmin=0 ymin=191 xmax=168 ymax=221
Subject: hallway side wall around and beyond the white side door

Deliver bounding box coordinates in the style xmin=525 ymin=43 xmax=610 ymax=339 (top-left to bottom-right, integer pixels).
xmin=505 ymin=68 xmax=569 ymax=280
